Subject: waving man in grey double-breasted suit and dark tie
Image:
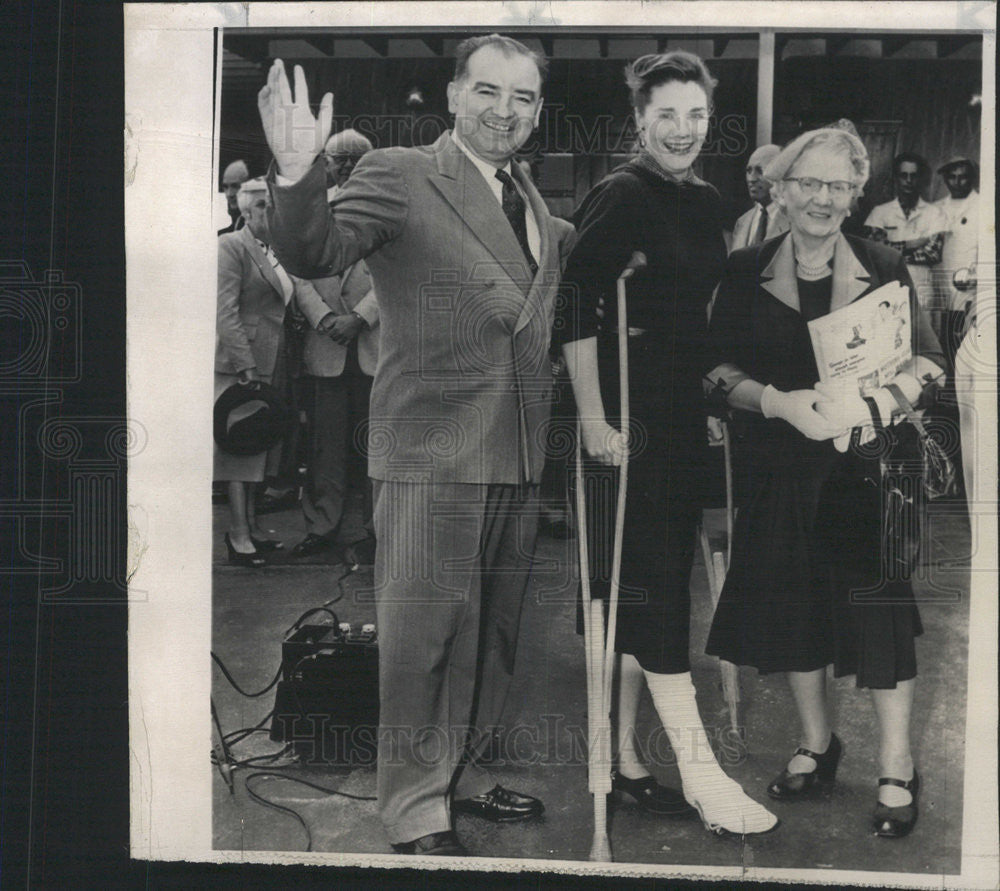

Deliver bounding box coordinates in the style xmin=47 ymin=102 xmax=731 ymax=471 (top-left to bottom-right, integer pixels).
xmin=258 ymin=34 xmax=572 ymax=855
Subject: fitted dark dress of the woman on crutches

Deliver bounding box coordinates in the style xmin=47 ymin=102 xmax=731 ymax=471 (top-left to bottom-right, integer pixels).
xmin=556 ymin=157 xmax=726 ymax=673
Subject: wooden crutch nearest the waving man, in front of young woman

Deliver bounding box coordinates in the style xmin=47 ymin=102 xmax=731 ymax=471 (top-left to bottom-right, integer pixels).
xmin=576 ymin=251 xmax=646 ymax=862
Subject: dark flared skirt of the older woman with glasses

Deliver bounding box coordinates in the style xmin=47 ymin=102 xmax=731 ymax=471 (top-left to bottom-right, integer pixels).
xmin=706 ymin=440 xmax=922 ymax=689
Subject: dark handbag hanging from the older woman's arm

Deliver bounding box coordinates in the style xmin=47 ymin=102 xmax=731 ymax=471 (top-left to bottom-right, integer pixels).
xmin=865 ymin=384 xmax=957 ymax=579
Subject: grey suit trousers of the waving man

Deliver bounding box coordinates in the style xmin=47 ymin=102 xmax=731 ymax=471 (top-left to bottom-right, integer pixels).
xmin=373 ymin=480 xmax=538 ymax=844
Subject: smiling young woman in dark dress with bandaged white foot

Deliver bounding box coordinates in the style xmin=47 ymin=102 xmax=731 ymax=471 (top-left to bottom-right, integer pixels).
xmin=559 ymin=52 xmax=777 ymax=834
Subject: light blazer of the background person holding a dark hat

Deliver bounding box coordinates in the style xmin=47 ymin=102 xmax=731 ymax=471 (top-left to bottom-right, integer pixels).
xmin=215 ymin=226 xmax=285 ymax=375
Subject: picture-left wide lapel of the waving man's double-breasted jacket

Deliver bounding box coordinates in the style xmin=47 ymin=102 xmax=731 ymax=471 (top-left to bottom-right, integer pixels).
xmin=430 ymin=132 xmax=541 ymax=291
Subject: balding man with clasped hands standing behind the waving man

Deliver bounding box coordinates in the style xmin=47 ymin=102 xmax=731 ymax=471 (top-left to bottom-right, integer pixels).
xmin=292 ymin=130 xmax=378 ymax=562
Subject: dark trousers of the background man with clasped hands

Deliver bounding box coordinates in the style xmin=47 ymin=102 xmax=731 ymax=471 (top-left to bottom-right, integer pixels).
xmin=301 ymin=368 xmax=372 ymax=544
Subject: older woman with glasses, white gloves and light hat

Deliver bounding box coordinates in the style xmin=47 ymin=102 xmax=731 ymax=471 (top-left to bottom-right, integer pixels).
xmin=705 ymin=129 xmax=944 ymax=838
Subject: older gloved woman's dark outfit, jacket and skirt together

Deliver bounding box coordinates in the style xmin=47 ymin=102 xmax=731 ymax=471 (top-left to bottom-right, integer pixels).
xmin=706 ymin=242 xmax=943 ymax=689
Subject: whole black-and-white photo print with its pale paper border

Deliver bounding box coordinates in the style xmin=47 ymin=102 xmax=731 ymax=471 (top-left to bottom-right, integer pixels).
xmin=124 ymin=2 xmax=1000 ymax=888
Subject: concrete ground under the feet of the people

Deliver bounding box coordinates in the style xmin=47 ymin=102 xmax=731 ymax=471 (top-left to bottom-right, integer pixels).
xmin=213 ymin=503 xmax=969 ymax=874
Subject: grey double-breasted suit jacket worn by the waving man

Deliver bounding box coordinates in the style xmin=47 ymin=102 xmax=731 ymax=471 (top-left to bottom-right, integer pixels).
xmin=268 ymin=133 xmax=572 ymax=483
